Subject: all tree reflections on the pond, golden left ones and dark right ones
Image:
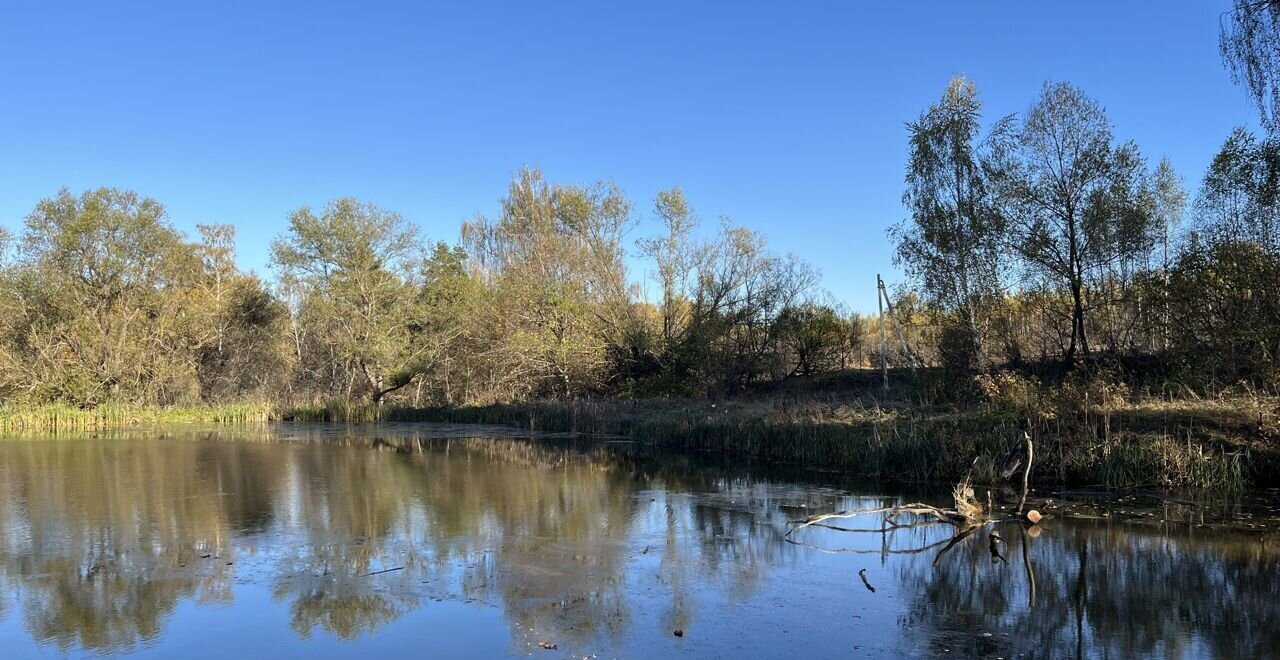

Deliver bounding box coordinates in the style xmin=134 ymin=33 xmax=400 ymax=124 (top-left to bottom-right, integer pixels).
xmin=0 ymin=427 xmax=1280 ymax=657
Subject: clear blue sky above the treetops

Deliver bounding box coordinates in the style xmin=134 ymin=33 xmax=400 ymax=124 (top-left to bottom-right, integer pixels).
xmin=0 ymin=0 xmax=1256 ymax=311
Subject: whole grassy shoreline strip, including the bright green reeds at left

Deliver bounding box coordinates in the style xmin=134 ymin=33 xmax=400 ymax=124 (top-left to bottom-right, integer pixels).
xmin=0 ymin=382 xmax=1280 ymax=491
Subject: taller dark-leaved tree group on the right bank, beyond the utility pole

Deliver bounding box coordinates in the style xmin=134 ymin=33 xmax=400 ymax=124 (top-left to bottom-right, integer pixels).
xmin=890 ymin=78 xmax=1280 ymax=388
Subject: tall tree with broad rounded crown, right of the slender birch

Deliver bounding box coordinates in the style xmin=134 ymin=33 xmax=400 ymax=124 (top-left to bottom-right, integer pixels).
xmin=991 ymin=82 xmax=1158 ymax=363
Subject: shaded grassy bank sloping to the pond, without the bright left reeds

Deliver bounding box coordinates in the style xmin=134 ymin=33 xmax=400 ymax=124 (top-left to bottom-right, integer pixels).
xmin=384 ymin=398 xmax=1280 ymax=491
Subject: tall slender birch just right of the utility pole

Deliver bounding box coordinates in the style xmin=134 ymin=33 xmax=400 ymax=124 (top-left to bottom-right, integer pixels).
xmin=890 ymin=78 xmax=1010 ymax=365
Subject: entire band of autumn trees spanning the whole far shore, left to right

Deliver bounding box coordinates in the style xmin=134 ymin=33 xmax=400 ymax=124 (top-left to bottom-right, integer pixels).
xmin=0 ymin=79 xmax=1280 ymax=407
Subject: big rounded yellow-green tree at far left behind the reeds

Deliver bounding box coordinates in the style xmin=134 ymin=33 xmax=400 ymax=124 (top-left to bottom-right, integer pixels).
xmin=9 ymin=188 xmax=207 ymax=405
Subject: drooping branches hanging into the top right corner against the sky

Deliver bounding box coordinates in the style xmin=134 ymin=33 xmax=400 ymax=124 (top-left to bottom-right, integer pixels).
xmin=1219 ymin=0 xmax=1280 ymax=128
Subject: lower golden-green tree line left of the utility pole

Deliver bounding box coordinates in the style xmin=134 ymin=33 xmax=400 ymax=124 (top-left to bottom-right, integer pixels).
xmin=0 ymin=169 xmax=865 ymax=407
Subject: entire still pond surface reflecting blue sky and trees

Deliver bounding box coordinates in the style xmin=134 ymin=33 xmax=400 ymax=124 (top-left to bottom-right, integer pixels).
xmin=0 ymin=425 xmax=1280 ymax=659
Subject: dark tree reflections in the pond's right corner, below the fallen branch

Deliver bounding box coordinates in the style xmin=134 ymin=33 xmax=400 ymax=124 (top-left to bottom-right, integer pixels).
xmin=897 ymin=511 xmax=1280 ymax=657
